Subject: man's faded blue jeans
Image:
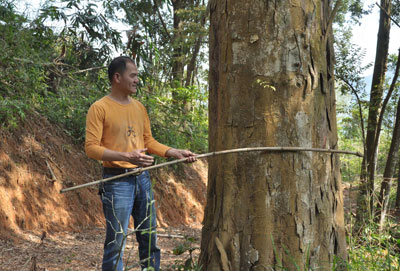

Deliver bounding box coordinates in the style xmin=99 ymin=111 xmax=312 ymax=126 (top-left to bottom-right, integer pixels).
xmin=100 ymin=171 xmax=160 ymax=271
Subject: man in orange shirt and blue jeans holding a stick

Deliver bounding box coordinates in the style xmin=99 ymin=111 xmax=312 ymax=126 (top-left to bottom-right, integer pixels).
xmin=85 ymin=56 xmax=196 ymax=271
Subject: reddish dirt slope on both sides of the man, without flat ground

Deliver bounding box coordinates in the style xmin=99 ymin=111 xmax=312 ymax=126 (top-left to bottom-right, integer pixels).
xmin=0 ymin=113 xmax=206 ymax=236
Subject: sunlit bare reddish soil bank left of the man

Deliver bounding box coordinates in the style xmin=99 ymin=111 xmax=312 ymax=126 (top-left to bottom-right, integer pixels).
xmin=0 ymin=111 xmax=101 ymax=233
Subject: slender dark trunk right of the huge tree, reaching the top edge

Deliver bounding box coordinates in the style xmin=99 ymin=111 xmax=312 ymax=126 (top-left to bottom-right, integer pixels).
xmin=357 ymin=0 xmax=392 ymax=219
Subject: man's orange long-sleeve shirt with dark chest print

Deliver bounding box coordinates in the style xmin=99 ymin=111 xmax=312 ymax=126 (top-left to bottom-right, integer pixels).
xmin=85 ymin=96 xmax=170 ymax=168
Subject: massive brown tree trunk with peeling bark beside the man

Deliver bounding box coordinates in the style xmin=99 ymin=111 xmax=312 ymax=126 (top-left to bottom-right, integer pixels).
xmin=200 ymin=0 xmax=346 ymax=271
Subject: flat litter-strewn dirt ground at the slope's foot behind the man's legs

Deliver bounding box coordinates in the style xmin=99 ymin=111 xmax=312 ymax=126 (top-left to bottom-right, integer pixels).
xmin=0 ymin=227 xmax=200 ymax=271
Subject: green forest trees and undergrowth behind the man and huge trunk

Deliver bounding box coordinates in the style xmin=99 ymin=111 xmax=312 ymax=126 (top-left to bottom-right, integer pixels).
xmin=0 ymin=0 xmax=400 ymax=270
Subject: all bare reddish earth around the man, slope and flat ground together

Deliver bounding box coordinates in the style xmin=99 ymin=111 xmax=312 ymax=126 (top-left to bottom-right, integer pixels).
xmin=0 ymin=113 xmax=207 ymax=270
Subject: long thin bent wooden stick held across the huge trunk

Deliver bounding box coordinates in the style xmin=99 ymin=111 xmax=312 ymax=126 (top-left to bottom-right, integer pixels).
xmin=60 ymin=147 xmax=363 ymax=193
